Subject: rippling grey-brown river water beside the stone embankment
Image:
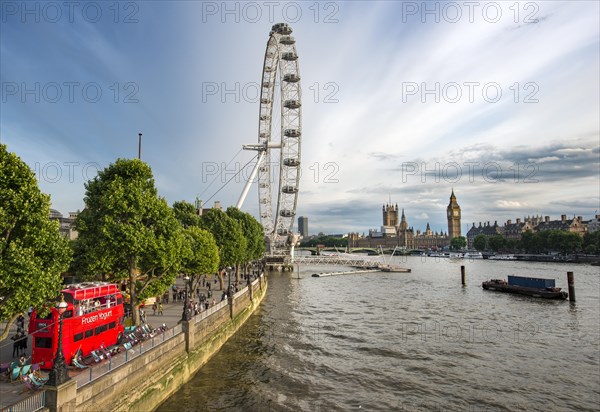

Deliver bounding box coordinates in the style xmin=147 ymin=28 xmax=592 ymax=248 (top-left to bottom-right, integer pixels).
xmin=158 ymin=257 xmax=600 ymax=412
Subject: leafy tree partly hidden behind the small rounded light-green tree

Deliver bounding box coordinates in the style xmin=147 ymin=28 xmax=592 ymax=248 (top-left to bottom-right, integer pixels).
xmin=200 ymin=209 xmax=247 ymax=289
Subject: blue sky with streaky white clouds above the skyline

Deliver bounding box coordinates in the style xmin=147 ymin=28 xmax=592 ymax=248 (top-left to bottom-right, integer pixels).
xmin=0 ymin=1 xmax=600 ymax=233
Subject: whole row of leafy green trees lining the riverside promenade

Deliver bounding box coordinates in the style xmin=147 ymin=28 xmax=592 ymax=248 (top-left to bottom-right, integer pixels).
xmin=0 ymin=149 xmax=265 ymax=337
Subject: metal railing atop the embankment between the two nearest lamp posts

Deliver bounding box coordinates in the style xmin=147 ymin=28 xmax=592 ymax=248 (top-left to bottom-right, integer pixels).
xmin=73 ymin=325 xmax=183 ymax=388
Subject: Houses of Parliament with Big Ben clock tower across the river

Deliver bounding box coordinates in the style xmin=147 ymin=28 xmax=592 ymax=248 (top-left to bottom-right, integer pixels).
xmin=348 ymin=190 xmax=461 ymax=249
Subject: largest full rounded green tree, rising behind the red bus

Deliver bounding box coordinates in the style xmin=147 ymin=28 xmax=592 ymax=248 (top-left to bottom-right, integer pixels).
xmin=75 ymin=159 xmax=183 ymax=325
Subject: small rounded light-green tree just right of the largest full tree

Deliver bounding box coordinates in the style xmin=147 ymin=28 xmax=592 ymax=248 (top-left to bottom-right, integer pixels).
xmin=181 ymin=226 xmax=219 ymax=296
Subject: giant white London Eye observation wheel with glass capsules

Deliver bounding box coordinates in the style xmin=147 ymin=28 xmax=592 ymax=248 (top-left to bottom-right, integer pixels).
xmin=238 ymin=23 xmax=302 ymax=255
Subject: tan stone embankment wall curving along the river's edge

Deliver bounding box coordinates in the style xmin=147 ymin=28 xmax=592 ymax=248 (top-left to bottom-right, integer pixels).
xmin=61 ymin=277 xmax=267 ymax=412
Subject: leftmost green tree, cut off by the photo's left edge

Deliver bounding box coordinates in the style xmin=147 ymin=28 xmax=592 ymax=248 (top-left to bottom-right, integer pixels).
xmin=0 ymin=144 xmax=71 ymax=340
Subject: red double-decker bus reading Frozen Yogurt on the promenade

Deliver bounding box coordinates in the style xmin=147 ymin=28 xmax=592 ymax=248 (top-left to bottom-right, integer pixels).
xmin=29 ymin=282 xmax=125 ymax=369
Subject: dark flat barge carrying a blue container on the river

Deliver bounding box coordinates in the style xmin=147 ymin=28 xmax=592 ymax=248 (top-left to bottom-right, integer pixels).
xmin=481 ymin=276 xmax=569 ymax=299
